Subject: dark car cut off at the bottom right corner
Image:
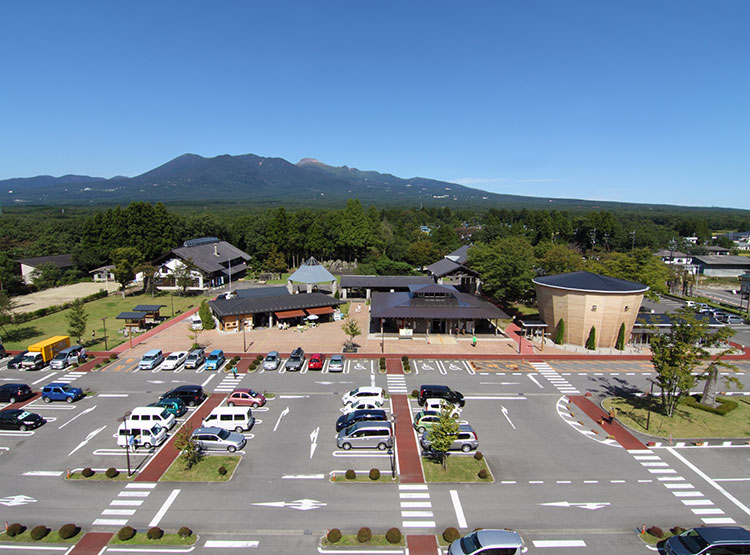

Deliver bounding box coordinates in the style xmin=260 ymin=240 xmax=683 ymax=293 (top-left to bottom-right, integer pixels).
xmin=664 ymin=526 xmax=750 ymax=555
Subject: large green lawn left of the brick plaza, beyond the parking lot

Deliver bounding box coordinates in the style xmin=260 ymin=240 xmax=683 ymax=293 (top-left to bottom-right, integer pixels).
xmin=3 ymin=293 xmax=204 ymax=351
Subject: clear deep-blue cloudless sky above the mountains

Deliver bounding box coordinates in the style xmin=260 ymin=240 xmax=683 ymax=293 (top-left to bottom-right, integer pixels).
xmin=0 ymin=0 xmax=750 ymax=208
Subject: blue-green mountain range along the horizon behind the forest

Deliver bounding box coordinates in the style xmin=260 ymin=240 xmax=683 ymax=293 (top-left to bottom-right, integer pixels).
xmin=0 ymin=154 xmax=740 ymax=210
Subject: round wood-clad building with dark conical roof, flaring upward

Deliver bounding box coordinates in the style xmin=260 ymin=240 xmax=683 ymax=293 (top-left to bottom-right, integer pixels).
xmin=532 ymin=272 xmax=648 ymax=348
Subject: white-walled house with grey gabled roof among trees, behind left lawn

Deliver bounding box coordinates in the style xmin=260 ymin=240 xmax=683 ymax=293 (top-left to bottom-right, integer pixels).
xmin=155 ymin=237 xmax=250 ymax=291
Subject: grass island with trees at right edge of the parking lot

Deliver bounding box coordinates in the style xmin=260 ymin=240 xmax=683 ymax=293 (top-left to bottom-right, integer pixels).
xmin=603 ymin=397 xmax=750 ymax=438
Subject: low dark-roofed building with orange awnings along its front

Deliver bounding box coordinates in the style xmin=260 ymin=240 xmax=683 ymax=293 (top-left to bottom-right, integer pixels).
xmin=208 ymin=286 xmax=344 ymax=331
